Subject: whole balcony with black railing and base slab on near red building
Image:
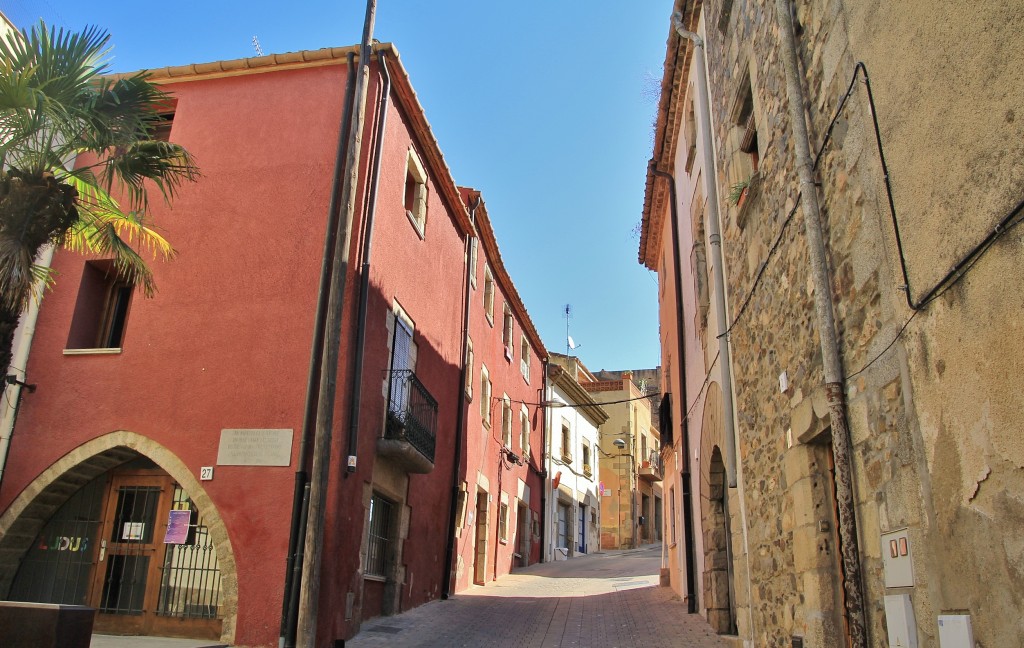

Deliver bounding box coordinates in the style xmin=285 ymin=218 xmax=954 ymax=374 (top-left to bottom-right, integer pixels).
xmin=377 ymin=370 xmax=437 ymax=474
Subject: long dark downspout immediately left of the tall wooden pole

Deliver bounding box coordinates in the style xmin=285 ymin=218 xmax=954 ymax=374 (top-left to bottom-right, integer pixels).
xmin=278 ymin=52 xmax=355 ymax=648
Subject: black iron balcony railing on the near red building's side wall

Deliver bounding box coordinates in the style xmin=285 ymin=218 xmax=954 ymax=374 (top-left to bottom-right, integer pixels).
xmin=384 ymin=370 xmax=437 ymax=463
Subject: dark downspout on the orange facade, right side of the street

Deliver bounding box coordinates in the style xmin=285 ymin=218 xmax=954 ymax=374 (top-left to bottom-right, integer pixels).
xmin=650 ymin=166 xmax=697 ymax=614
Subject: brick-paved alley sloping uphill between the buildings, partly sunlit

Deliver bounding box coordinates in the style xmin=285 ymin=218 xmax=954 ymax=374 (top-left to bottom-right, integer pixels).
xmin=346 ymin=546 xmax=726 ymax=648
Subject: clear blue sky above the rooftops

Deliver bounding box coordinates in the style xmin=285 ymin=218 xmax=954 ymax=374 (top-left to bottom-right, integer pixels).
xmin=6 ymin=0 xmax=672 ymax=371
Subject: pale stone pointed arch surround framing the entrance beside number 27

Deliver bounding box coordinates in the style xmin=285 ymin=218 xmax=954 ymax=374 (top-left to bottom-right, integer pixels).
xmin=0 ymin=430 xmax=239 ymax=643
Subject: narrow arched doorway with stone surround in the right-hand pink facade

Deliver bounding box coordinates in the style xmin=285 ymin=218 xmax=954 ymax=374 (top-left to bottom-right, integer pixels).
xmin=700 ymin=382 xmax=735 ymax=635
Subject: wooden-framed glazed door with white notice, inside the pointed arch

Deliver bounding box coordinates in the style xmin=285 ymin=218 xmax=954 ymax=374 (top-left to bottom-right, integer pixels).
xmin=90 ymin=472 xmax=173 ymax=635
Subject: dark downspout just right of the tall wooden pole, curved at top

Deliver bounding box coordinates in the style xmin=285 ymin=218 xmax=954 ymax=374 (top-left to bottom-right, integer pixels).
xmin=343 ymin=45 xmax=391 ymax=470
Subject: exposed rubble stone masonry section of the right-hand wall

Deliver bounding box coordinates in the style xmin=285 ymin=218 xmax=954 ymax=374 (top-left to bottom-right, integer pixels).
xmin=706 ymin=0 xmax=918 ymax=646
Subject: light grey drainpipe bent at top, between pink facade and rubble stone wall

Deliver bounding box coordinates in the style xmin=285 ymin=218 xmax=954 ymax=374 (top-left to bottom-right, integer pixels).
xmin=672 ymin=13 xmax=736 ymax=488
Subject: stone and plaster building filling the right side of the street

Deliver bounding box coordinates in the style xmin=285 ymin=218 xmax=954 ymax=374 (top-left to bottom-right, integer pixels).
xmin=640 ymin=0 xmax=1024 ymax=646
